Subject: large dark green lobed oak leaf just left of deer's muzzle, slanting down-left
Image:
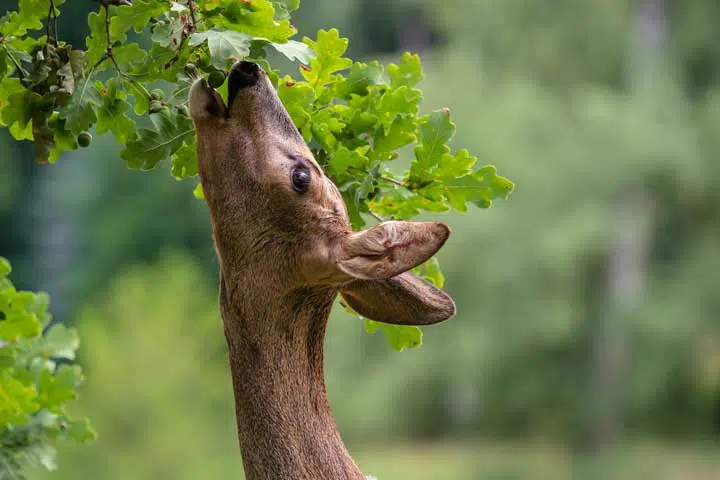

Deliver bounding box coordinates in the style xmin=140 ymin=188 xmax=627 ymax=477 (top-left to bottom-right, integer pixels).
xmin=120 ymin=109 xmax=195 ymax=170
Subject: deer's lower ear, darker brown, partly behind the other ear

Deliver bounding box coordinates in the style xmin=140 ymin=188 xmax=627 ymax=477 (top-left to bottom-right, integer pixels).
xmin=340 ymin=272 xmax=455 ymax=325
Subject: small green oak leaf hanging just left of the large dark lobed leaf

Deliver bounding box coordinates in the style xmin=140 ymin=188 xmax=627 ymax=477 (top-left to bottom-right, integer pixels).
xmin=95 ymin=77 xmax=135 ymax=145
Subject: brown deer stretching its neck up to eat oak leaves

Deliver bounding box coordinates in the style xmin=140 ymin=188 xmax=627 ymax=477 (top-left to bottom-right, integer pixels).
xmin=188 ymin=61 xmax=456 ymax=480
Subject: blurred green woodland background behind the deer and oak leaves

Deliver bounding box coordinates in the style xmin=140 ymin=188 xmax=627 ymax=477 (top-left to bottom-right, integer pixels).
xmin=0 ymin=0 xmax=720 ymax=480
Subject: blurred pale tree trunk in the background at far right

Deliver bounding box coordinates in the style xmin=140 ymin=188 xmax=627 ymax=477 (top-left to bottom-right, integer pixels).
xmin=582 ymin=0 xmax=667 ymax=454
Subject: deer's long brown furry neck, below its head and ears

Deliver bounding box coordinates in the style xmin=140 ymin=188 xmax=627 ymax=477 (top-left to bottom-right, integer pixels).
xmin=220 ymin=282 xmax=365 ymax=480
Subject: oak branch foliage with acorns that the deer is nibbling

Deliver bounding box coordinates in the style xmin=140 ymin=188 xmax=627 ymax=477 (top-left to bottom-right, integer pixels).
xmin=0 ymin=0 xmax=514 ymax=350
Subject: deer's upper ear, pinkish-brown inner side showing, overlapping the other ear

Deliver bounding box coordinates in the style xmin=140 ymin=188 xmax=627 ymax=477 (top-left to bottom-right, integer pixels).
xmin=338 ymin=221 xmax=450 ymax=280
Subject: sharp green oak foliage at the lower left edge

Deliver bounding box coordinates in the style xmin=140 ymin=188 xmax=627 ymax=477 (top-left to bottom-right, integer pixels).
xmin=0 ymin=257 xmax=95 ymax=479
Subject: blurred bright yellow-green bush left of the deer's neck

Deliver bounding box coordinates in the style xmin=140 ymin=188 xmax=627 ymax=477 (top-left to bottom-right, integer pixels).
xmin=26 ymin=251 xmax=236 ymax=480
